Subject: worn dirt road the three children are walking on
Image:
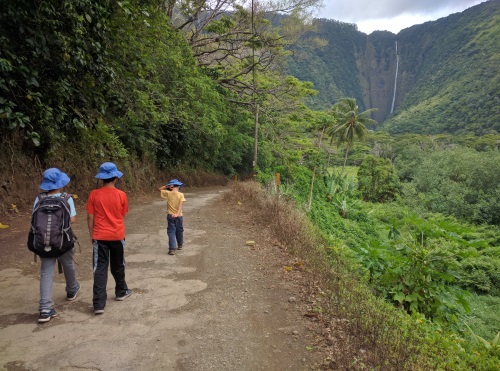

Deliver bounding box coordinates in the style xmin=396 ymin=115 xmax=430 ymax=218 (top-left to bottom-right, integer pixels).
xmin=0 ymin=188 xmax=320 ymax=370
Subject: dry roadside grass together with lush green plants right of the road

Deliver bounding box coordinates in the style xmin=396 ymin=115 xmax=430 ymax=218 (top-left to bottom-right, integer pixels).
xmin=228 ymin=151 xmax=500 ymax=370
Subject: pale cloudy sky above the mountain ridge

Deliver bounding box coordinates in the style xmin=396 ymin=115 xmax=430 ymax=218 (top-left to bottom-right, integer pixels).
xmin=316 ymin=0 xmax=485 ymax=34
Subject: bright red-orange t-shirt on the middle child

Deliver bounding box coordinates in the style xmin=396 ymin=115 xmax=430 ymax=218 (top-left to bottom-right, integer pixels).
xmin=87 ymin=187 xmax=128 ymax=241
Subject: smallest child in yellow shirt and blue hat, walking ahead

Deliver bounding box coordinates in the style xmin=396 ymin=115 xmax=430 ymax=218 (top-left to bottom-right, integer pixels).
xmin=158 ymin=179 xmax=186 ymax=255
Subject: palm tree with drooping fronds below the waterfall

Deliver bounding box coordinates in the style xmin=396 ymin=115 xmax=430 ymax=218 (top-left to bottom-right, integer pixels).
xmin=328 ymin=98 xmax=377 ymax=173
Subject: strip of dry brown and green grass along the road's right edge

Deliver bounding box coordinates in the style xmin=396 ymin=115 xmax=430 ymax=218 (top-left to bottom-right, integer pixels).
xmin=226 ymin=182 xmax=498 ymax=370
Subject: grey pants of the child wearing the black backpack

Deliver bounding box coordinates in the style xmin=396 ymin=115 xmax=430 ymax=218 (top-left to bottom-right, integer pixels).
xmin=39 ymin=249 xmax=80 ymax=312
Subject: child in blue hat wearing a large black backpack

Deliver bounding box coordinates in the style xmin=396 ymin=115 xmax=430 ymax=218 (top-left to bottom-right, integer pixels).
xmin=28 ymin=168 xmax=80 ymax=323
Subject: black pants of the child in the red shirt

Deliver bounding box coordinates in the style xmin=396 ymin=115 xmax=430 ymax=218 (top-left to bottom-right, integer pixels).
xmin=93 ymin=240 xmax=128 ymax=309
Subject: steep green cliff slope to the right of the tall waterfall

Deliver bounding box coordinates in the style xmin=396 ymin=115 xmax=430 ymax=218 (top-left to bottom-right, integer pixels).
xmin=384 ymin=0 xmax=500 ymax=134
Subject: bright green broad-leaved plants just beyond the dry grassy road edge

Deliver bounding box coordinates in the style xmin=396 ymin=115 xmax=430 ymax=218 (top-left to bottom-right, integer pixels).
xmin=258 ymin=156 xmax=499 ymax=330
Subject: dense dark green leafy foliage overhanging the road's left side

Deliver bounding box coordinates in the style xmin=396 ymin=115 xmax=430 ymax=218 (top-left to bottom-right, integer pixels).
xmin=0 ymin=0 xmax=251 ymax=174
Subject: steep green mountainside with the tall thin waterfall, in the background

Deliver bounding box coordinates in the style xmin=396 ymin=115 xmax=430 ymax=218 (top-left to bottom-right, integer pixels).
xmin=289 ymin=0 xmax=500 ymax=135
